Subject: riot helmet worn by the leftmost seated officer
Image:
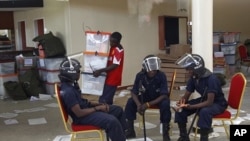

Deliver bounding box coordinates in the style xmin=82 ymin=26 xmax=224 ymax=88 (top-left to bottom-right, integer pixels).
xmin=59 ymin=58 xmax=81 ymax=82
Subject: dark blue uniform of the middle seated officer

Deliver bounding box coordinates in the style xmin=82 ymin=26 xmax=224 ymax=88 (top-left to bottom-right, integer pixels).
xmin=125 ymin=71 xmax=171 ymax=123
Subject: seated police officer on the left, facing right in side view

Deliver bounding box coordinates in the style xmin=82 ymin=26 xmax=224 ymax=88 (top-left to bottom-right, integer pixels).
xmin=59 ymin=59 xmax=126 ymax=141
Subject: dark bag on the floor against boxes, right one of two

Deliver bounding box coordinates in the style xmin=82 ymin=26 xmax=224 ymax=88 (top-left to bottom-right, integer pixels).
xmin=19 ymin=69 xmax=45 ymax=97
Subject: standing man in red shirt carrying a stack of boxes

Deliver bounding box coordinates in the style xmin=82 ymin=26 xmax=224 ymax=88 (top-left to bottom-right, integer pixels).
xmin=93 ymin=32 xmax=124 ymax=105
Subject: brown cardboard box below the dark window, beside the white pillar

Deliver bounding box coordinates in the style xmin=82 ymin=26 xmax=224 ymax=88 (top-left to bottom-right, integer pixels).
xmin=170 ymin=44 xmax=191 ymax=58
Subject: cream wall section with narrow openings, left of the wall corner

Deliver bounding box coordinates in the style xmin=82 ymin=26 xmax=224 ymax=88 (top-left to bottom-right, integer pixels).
xmin=14 ymin=0 xmax=68 ymax=50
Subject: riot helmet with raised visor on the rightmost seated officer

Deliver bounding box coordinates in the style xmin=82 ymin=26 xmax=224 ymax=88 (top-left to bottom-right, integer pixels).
xmin=176 ymin=53 xmax=208 ymax=78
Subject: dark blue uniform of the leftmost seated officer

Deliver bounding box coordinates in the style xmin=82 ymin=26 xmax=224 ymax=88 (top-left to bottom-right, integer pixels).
xmin=61 ymin=83 xmax=126 ymax=141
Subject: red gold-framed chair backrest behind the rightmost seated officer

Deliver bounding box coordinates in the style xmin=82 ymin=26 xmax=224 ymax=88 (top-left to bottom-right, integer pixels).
xmin=228 ymin=72 xmax=247 ymax=112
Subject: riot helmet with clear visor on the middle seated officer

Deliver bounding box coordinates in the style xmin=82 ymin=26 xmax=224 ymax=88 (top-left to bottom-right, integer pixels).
xmin=142 ymin=55 xmax=161 ymax=72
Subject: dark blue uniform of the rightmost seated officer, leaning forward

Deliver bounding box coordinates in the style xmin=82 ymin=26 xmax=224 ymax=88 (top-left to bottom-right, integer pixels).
xmin=175 ymin=74 xmax=227 ymax=129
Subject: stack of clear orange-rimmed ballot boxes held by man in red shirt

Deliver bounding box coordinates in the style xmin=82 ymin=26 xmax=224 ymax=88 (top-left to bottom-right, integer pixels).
xmin=81 ymin=32 xmax=110 ymax=95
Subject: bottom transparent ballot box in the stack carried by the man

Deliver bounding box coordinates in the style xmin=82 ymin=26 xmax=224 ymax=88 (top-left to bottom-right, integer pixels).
xmin=81 ymin=72 xmax=106 ymax=96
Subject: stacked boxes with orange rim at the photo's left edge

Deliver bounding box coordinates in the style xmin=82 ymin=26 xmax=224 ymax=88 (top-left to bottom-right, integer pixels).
xmin=0 ymin=61 xmax=18 ymax=99
